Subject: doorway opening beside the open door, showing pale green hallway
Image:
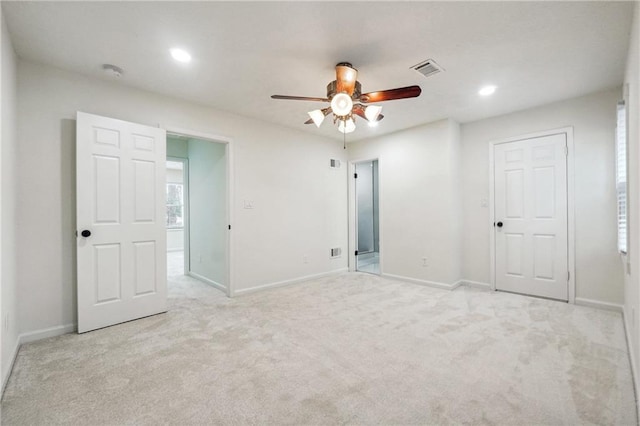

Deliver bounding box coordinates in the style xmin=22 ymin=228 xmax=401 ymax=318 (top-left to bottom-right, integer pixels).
xmin=166 ymin=132 xmax=231 ymax=296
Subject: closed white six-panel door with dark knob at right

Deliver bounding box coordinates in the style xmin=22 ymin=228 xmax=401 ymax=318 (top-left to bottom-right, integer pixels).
xmin=493 ymin=133 xmax=569 ymax=300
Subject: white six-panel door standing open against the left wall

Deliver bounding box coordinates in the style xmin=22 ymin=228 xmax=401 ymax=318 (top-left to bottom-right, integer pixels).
xmin=76 ymin=112 xmax=167 ymax=333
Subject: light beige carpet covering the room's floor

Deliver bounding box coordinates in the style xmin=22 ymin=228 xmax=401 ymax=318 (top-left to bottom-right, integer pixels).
xmin=2 ymin=274 xmax=636 ymax=425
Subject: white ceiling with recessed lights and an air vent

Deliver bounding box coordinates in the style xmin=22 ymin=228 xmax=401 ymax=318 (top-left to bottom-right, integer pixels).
xmin=2 ymin=1 xmax=634 ymax=140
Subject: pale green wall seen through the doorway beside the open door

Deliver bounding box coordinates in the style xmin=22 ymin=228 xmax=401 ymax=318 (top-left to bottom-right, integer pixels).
xmin=188 ymin=139 xmax=228 ymax=288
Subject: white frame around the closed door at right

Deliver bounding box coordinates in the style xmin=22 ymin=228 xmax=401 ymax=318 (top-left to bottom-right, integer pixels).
xmin=487 ymin=126 xmax=576 ymax=304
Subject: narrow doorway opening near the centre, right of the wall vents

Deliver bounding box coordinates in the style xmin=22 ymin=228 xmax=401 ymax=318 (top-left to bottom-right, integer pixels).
xmin=354 ymin=160 xmax=380 ymax=275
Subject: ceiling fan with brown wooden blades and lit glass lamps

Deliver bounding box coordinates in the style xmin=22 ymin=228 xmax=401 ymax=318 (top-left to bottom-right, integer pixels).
xmin=271 ymin=62 xmax=422 ymax=133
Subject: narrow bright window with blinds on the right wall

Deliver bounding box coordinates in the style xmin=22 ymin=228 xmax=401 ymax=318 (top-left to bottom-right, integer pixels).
xmin=616 ymin=102 xmax=627 ymax=253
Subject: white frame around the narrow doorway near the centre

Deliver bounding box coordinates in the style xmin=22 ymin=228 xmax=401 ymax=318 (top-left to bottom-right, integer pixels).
xmin=347 ymin=157 xmax=384 ymax=276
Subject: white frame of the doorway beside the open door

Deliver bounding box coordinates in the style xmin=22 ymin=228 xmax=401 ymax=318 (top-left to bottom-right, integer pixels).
xmin=164 ymin=126 xmax=235 ymax=297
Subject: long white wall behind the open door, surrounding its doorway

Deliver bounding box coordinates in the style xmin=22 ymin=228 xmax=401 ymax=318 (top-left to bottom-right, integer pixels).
xmin=17 ymin=60 xmax=347 ymax=332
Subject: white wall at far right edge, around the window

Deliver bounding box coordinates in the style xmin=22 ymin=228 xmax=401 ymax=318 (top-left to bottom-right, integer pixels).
xmin=621 ymin=4 xmax=640 ymax=398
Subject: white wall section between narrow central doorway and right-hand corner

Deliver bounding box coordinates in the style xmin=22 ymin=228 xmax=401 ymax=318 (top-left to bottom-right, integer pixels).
xmin=348 ymin=120 xmax=461 ymax=285
